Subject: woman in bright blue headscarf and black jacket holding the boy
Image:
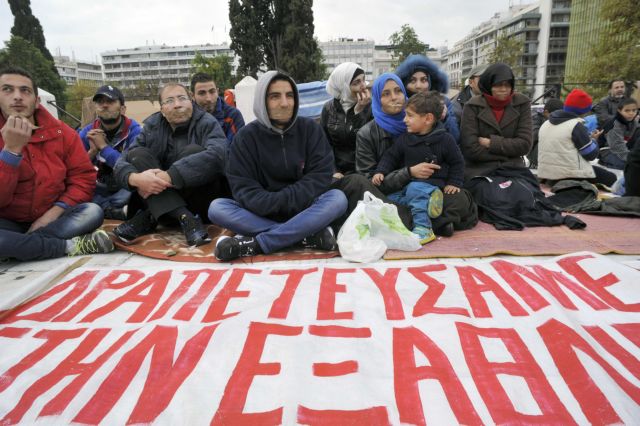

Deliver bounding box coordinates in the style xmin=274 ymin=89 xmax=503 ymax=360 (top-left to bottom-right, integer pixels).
xmin=356 ymin=73 xmax=478 ymax=237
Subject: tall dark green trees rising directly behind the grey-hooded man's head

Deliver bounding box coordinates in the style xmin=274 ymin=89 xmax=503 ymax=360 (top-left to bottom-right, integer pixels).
xmin=229 ymin=0 xmax=325 ymax=82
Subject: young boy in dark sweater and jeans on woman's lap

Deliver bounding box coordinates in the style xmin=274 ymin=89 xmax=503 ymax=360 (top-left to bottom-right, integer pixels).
xmin=371 ymin=91 xmax=464 ymax=244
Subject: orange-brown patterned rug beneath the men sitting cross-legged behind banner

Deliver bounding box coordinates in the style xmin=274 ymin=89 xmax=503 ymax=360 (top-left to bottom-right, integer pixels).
xmin=102 ymin=220 xmax=340 ymax=263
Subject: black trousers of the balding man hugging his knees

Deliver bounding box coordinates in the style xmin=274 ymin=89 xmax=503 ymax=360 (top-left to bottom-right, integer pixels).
xmin=127 ymin=144 xmax=231 ymax=222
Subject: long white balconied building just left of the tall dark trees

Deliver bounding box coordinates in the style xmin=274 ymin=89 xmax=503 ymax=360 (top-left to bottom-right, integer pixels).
xmin=101 ymin=43 xmax=238 ymax=88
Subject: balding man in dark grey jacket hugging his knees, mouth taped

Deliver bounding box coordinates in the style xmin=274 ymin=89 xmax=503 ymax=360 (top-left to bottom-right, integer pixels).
xmin=114 ymin=83 xmax=229 ymax=246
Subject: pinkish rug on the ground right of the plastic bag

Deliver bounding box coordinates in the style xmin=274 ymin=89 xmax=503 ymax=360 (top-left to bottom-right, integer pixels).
xmin=384 ymin=214 xmax=640 ymax=260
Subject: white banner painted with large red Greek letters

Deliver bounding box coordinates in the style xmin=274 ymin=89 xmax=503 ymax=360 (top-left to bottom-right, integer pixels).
xmin=0 ymin=253 xmax=640 ymax=425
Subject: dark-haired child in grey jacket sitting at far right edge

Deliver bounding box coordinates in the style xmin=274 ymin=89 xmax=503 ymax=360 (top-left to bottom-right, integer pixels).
xmin=600 ymin=98 xmax=640 ymax=170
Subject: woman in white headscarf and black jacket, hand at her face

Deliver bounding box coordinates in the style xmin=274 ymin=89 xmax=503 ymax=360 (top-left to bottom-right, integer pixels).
xmin=320 ymin=62 xmax=372 ymax=179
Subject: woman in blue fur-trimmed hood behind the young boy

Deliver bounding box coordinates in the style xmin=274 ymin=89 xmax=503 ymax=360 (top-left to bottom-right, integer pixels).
xmin=396 ymin=55 xmax=460 ymax=143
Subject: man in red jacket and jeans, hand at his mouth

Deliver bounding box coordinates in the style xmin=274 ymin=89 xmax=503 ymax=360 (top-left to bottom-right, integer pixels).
xmin=0 ymin=68 xmax=113 ymax=260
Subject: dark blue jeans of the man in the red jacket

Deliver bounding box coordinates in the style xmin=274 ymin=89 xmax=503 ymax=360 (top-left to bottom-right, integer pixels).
xmin=0 ymin=203 xmax=103 ymax=261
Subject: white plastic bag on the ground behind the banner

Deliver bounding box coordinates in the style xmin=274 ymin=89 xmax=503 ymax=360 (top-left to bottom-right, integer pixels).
xmin=338 ymin=191 xmax=422 ymax=263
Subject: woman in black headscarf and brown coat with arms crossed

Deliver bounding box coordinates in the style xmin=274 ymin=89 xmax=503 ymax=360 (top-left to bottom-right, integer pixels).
xmin=460 ymin=63 xmax=532 ymax=181
